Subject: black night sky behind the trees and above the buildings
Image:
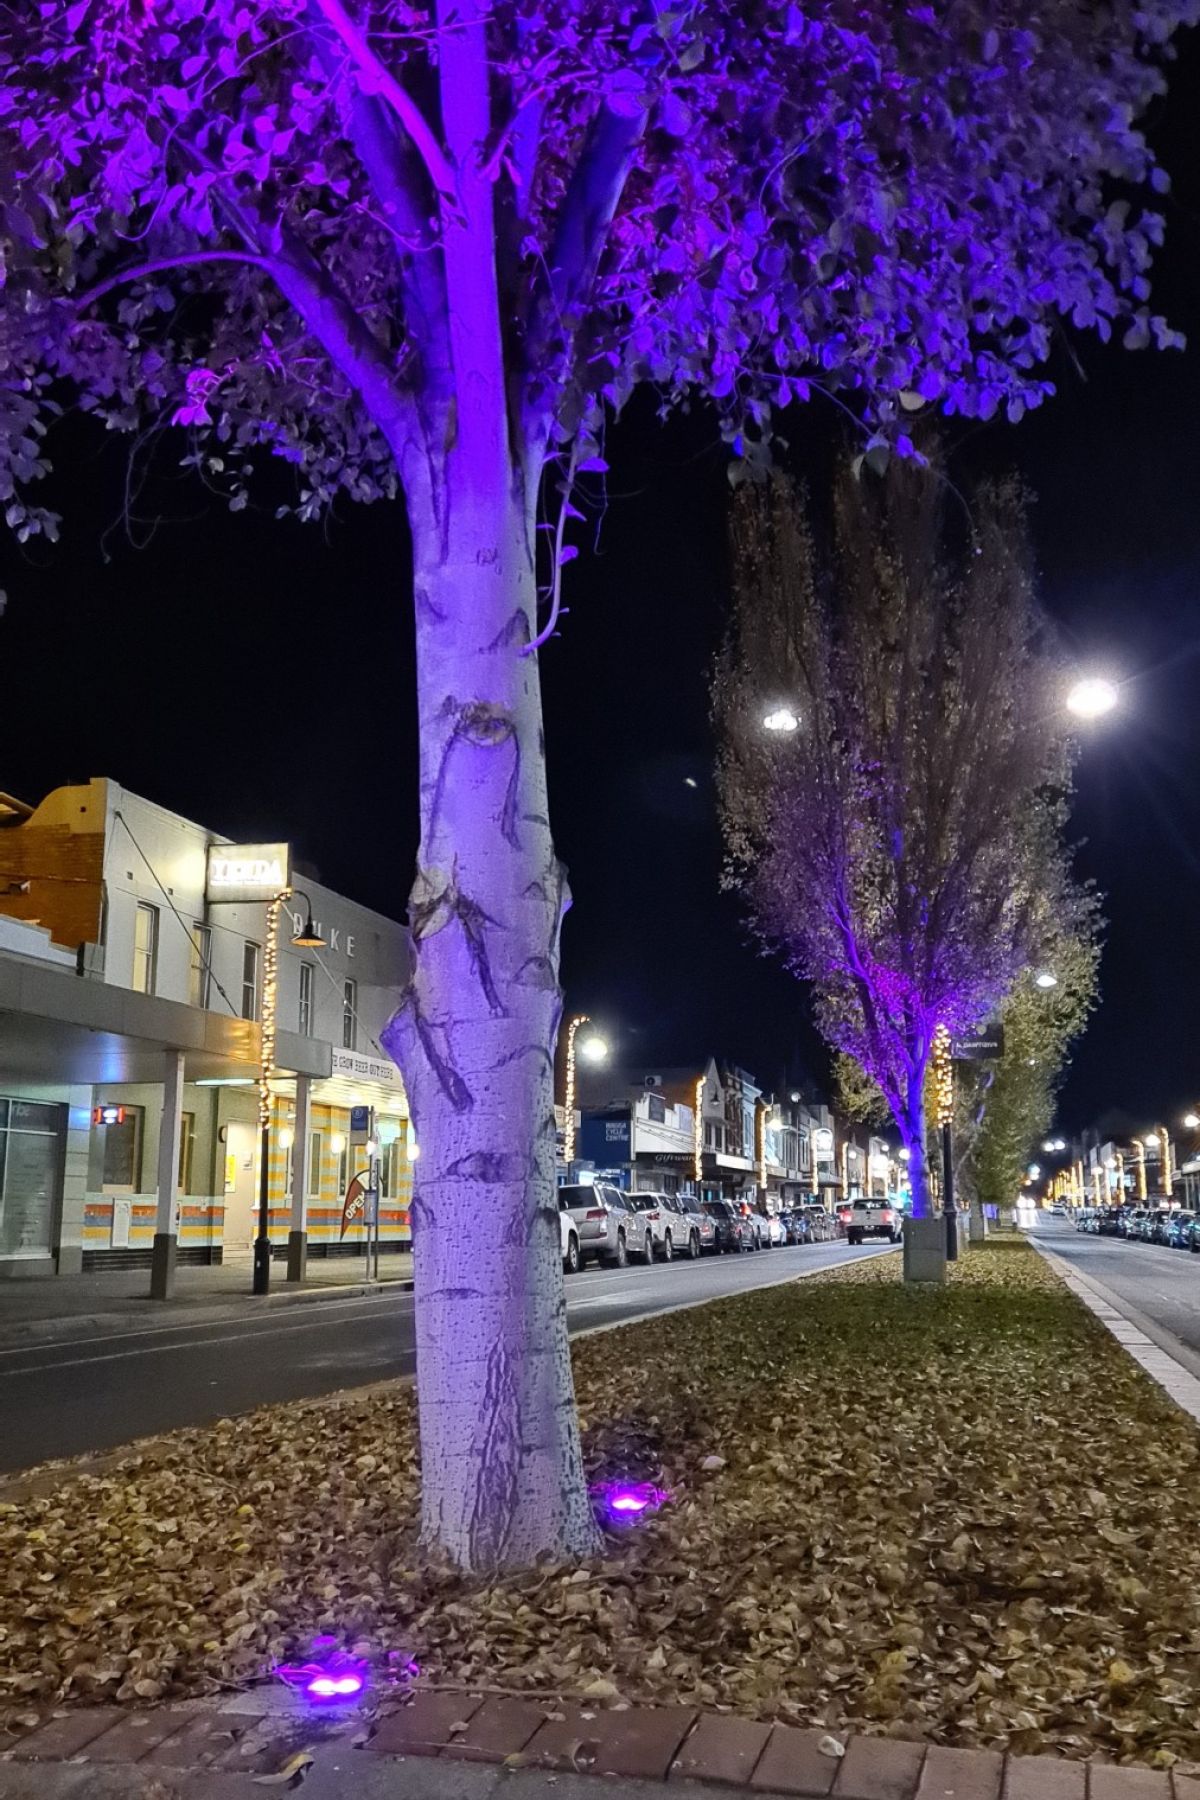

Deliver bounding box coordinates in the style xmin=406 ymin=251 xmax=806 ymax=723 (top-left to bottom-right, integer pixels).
xmin=0 ymin=34 xmax=1200 ymax=1129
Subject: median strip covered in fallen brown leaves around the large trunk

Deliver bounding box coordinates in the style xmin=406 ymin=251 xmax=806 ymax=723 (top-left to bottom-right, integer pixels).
xmin=0 ymin=1240 xmax=1200 ymax=1766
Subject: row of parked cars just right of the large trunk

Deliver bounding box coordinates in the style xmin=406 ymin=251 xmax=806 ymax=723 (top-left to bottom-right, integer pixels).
xmin=558 ymin=1181 xmax=851 ymax=1274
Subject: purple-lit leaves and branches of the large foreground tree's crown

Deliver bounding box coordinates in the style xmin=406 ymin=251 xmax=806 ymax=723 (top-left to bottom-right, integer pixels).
xmin=0 ymin=0 xmax=1198 ymax=536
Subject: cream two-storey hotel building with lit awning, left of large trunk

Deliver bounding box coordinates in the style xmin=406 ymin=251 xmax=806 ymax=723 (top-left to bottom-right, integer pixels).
xmin=0 ymin=779 xmax=416 ymax=1274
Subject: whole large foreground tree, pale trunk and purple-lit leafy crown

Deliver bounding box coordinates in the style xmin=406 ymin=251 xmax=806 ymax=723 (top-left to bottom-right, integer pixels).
xmin=0 ymin=0 xmax=1196 ymax=1568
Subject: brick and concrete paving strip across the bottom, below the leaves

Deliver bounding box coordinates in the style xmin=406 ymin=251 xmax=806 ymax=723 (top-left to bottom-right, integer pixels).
xmin=0 ymin=1685 xmax=1180 ymax=1800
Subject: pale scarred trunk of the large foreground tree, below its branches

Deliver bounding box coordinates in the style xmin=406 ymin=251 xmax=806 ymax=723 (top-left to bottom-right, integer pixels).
xmin=389 ymin=473 xmax=597 ymax=1570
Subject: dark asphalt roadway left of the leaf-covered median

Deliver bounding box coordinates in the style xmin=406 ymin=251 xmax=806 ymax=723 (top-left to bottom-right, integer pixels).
xmin=0 ymin=1242 xmax=883 ymax=1471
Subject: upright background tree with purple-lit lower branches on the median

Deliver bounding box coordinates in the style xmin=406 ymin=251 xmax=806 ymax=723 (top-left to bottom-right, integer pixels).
xmin=714 ymin=464 xmax=1070 ymax=1217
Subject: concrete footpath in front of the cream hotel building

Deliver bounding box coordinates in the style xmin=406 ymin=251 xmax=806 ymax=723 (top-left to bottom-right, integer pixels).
xmin=0 ymin=1253 xmax=412 ymax=1345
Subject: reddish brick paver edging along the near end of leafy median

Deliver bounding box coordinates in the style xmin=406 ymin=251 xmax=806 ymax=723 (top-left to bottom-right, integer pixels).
xmin=0 ymin=1688 xmax=1200 ymax=1800
